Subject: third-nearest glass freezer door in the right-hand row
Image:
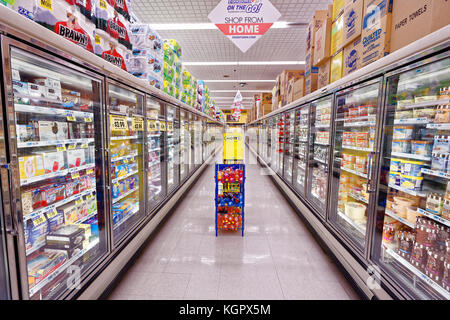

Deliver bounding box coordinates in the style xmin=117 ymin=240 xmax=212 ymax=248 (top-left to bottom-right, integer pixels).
xmin=307 ymin=96 xmax=333 ymax=216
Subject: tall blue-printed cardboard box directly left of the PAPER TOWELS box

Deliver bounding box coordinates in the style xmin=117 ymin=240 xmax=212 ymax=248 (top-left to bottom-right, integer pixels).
xmin=361 ymin=0 xmax=393 ymax=67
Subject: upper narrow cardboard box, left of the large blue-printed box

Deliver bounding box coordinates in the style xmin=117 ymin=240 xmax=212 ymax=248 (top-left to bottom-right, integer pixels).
xmin=342 ymin=0 xmax=364 ymax=47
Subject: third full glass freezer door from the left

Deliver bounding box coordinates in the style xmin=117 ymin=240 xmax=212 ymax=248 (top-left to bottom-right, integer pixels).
xmin=146 ymin=96 xmax=166 ymax=213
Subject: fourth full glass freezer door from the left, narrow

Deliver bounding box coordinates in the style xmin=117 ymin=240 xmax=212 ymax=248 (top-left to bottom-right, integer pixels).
xmin=166 ymin=106 xmax=180 ymax=193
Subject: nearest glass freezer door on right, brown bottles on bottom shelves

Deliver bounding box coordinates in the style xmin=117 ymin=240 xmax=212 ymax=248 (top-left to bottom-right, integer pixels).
xmin=371 ymin=55 xmax=450 ymax=300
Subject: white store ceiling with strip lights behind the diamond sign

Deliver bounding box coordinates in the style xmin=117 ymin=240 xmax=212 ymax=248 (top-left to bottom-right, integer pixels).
xmin=132 ymin=0 xmax=332 ymax=106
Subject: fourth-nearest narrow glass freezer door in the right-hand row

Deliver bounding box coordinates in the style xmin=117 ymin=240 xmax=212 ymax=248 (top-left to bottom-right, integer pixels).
xmin=293 ymin=105 xmax=309 ymax=195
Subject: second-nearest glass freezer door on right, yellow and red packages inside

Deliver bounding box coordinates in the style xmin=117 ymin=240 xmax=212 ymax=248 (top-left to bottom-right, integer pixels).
xmin=329 ymin=81 xmax=380 ymax=251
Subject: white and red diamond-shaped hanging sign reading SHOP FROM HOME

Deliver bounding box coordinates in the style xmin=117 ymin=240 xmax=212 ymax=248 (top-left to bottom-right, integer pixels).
xmin=208 ymin=0 xmax=281 ymax=53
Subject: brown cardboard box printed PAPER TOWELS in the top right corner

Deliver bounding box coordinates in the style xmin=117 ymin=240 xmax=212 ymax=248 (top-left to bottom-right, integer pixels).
xmin=391 ymin=0 xmax=450 ymax=52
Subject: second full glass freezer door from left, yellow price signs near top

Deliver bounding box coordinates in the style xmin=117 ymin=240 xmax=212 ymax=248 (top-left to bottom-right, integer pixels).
xmin=108 ymin=84 xmax=145 ymax=243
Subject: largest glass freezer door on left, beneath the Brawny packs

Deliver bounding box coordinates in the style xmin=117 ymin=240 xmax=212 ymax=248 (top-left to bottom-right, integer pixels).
xmin=5 ymin=46 xmax=107 ymax=300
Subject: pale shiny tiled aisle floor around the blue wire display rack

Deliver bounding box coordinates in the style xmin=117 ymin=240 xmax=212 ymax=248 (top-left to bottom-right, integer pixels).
xmin=109 ymin=150 xmax=358 ymax=300
